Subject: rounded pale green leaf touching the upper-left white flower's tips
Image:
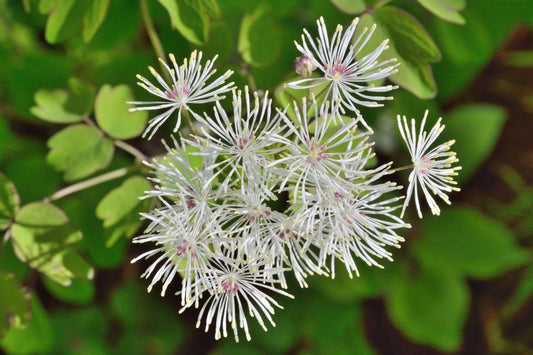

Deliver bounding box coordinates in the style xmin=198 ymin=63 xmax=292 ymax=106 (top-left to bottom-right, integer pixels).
xmin=94 ymin=85 xmax=148 ymax=139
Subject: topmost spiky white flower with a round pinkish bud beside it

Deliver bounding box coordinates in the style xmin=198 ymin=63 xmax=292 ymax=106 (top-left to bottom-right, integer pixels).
xmin=287 ymin=17 xmax=398 ymax=117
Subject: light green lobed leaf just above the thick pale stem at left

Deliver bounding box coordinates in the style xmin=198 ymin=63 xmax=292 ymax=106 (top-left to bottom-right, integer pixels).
xmin=46 ymin=124 xmax=114 ymax=181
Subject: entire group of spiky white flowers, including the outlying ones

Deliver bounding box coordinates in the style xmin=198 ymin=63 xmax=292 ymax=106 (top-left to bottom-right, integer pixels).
xmin=132 ymin=18 xmax=458 ymax=341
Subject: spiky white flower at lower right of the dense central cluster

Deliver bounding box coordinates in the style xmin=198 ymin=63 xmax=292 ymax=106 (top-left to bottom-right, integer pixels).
xmin=298 ymin=164 xmax=410 ymax=278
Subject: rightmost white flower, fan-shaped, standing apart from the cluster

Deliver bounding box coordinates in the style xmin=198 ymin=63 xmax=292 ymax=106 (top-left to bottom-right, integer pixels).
xmin=398 ymin=110 xmax=461 ymax=218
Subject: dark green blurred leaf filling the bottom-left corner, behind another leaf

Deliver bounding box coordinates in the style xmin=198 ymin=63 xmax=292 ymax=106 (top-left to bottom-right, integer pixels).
xmin=0 ymin=294 xmax=54 ymax=354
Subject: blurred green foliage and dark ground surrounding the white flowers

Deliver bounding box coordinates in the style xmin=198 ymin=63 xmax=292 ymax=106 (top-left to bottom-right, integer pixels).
xmin=0 ymin=0 xmax=533 ymax=354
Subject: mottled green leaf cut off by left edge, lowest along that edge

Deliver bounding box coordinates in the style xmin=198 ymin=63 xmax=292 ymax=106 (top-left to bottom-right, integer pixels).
xmin=0 ymin=270 xmax=31 ymax=339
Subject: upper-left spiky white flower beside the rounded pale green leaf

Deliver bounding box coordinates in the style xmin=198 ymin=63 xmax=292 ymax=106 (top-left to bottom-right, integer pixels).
xmin=128 ymin=51 xmax=233 ymax=139
